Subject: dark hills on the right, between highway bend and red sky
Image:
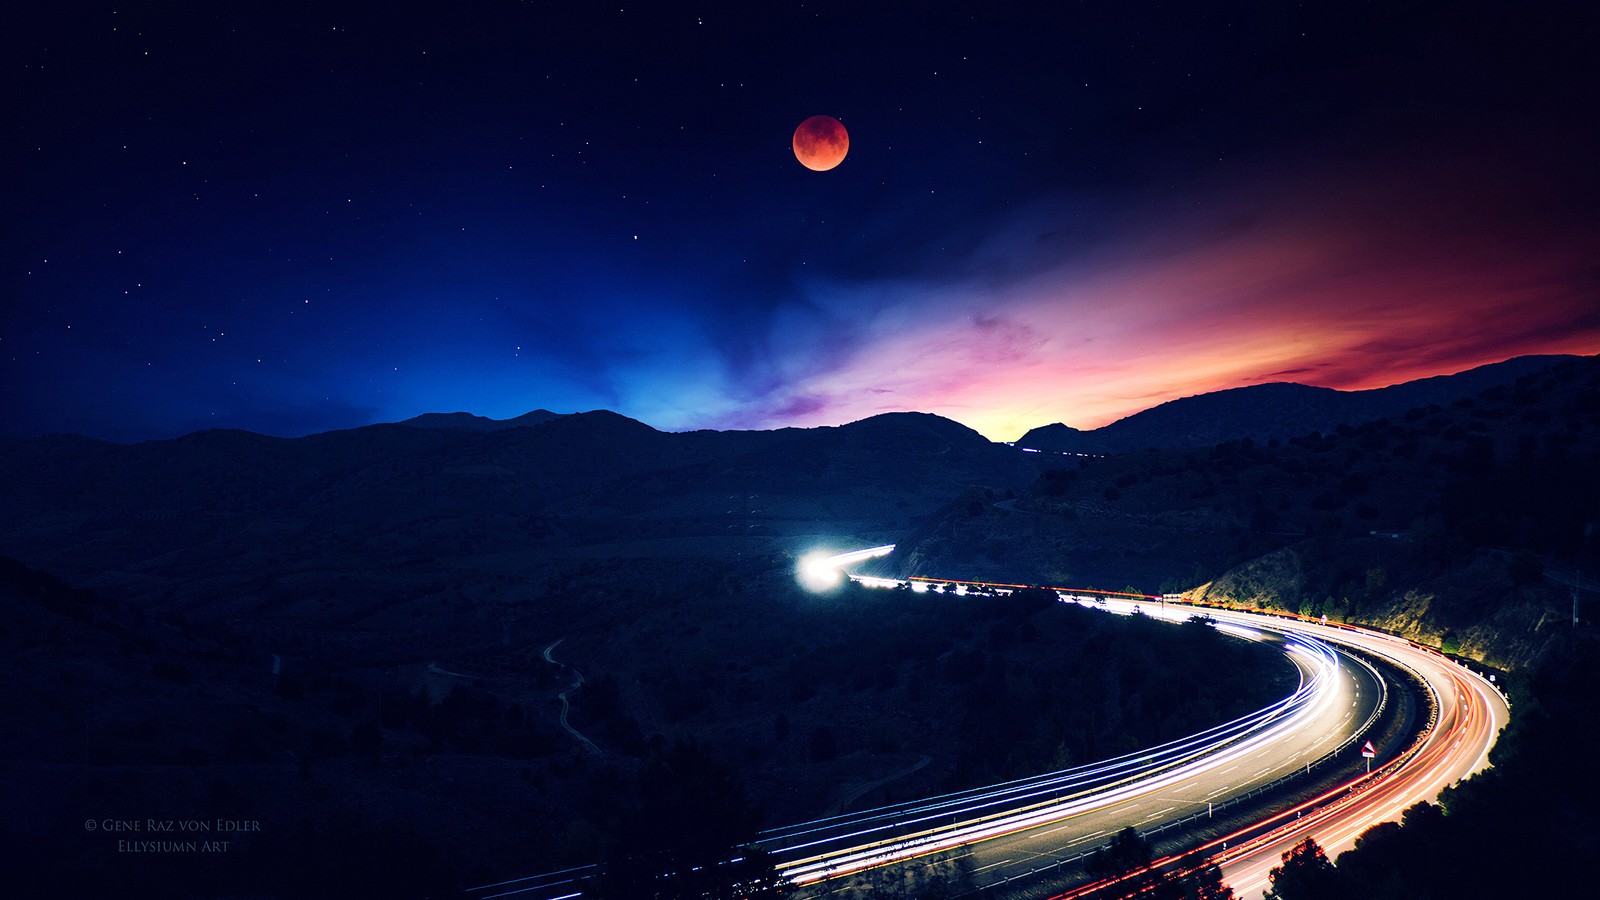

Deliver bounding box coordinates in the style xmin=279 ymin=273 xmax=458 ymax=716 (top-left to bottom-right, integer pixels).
xmin=885 ymin=357 xmax=1600 ymax=666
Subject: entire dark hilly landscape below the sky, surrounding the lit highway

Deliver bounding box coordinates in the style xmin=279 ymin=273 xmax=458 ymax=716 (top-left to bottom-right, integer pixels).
xmin=0 ymin=359 xmax=1600 ymax=897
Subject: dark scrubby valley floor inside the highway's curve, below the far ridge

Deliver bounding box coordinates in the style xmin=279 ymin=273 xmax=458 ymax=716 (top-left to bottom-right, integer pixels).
xmin=0 ymin=560 xmax=1294 ymax=897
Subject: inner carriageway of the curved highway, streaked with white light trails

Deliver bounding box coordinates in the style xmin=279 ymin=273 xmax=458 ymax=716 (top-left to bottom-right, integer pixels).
xmin=760 ymin=599 xmax=1384 ymax=884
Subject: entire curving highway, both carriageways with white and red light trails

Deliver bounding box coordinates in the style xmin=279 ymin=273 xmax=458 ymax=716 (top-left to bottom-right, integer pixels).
xmin=470 ymin=548 xmax=1509 ymax=900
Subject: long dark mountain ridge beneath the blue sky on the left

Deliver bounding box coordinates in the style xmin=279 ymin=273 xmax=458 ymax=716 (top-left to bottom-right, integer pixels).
xmin=0 ymin=410 xmax=1037 ymax=608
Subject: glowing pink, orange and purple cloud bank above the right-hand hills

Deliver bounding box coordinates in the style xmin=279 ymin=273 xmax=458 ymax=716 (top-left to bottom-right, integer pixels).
xmin=710 ymin=150 xmax=1600 ymax=439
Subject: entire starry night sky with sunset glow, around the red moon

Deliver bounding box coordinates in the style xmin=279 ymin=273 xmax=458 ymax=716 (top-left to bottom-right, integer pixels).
xmin=0 ymin=0 xmax=1600 ymax=440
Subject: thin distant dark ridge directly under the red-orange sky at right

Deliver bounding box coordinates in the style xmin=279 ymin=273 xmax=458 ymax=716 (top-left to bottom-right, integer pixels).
xmin=1016 ymin=356 xmax=1579 ymax=453
